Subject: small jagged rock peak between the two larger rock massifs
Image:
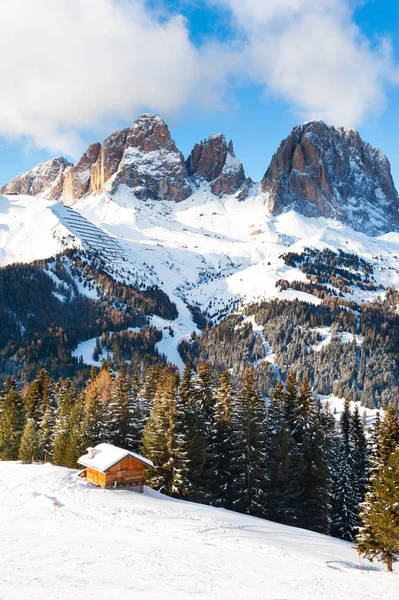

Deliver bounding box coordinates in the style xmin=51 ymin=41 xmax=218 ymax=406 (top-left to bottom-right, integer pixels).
xmin=186 ymin=133 xmax=248 ymax=196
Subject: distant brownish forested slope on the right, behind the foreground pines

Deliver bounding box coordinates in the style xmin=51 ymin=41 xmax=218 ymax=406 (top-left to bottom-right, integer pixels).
xmin=186 ymin=290 xmax=399 ymax=408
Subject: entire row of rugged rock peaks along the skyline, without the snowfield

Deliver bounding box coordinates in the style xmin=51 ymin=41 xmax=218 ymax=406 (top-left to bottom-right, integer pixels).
xmin=0 ymin=114 xmax=399 ymax=235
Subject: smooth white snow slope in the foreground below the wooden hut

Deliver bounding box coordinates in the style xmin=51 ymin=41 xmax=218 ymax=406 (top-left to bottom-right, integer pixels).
xmin=0 ymin=462 xmax=399 ymax=600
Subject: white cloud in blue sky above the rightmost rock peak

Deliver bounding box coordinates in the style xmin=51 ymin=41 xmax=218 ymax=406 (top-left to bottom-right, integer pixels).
xmin=211 ymin=0 xmax=398 ymax=126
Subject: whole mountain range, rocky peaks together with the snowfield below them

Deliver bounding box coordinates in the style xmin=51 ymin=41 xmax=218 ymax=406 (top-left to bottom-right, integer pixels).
xmin=0 ymin=115 xmax=399 ymax=386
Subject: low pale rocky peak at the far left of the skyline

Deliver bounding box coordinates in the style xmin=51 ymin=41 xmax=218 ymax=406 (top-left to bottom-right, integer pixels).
xmin=0 ymin=156 xmax=72 ymax=200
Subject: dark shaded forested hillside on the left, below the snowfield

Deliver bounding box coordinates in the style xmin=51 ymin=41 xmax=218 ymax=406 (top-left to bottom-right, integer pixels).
xmin=0 ymin=251 xmax=177 ymax=381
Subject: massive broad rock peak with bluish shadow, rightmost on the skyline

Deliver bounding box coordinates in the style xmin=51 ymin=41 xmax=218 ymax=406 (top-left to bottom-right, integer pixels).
xmin=262 ymin=121 xmax=399 ymax=235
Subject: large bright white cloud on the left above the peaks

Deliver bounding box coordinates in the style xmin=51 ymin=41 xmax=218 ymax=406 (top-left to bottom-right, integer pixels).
xmin=0 ymin=0 xmax=234 ymax=155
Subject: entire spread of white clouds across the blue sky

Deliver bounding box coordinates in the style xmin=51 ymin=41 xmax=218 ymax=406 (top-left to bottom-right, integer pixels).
xmin=0 ymin=0 xmax=398 ymax=155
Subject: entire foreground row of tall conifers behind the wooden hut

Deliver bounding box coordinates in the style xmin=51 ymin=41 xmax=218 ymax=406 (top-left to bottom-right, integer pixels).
xmin=0 ymin=362 xmax=399 ymax=569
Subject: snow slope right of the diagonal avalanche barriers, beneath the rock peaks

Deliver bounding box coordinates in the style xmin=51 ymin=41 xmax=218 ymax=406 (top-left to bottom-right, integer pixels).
xmin=74 ymin=185 xmax=399 ymax=317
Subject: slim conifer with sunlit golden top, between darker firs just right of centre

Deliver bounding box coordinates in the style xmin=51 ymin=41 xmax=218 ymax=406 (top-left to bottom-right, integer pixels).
xmin=209 ymin=371 xmax=235 ymax=508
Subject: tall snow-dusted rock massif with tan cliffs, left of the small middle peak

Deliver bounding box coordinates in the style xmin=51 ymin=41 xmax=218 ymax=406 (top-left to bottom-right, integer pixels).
xmin=89 ymin=115 xmax=192 ymax=201
